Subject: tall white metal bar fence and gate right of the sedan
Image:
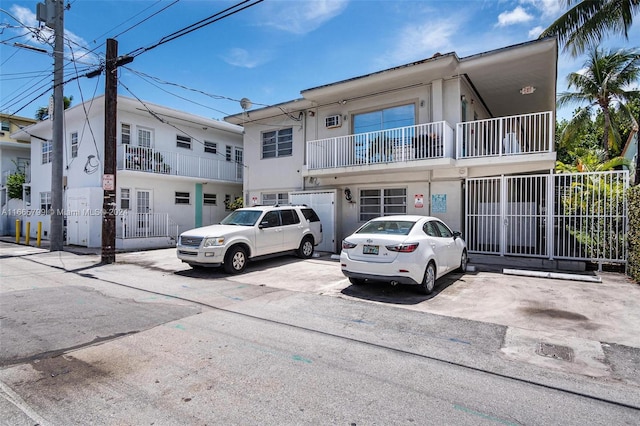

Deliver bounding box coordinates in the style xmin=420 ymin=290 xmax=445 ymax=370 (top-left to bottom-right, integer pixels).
xmin=466 ymin=171 xmax=629 ymax=263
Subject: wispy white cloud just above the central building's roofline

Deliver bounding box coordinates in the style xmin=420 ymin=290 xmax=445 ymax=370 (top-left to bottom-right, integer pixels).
xmin=384 ymin=19 xmax=459 ymax=64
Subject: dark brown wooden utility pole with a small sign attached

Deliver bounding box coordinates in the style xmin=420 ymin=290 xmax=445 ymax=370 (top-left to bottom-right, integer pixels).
xmin=102 ymin=38 xmax=118 ymax=263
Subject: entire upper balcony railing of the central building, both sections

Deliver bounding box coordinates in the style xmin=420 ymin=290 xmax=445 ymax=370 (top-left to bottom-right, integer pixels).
xmin=307 ymin=112 xmax=554 ymax=170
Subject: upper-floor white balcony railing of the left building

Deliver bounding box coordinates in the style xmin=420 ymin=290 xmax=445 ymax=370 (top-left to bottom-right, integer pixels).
xmin=117 ymin=145 xmax=243 ymax=183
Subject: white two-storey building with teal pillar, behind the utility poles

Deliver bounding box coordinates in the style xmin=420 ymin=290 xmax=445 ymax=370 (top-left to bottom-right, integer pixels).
xmin=16 ymin=96 xmax=243 ymax=249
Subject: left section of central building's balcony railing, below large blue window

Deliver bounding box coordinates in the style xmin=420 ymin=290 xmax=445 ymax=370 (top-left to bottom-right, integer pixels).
xmin=307 ymin=121 xmax=454 ymax=170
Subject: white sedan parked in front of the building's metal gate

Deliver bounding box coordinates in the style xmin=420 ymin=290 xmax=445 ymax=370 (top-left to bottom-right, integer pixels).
xmin=340 ymin=215 xmax=467 ymax=294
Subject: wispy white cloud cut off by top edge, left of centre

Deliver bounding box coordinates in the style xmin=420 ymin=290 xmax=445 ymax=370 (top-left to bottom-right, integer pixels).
xmin=266 ymin=0 xmax=349 ymax=34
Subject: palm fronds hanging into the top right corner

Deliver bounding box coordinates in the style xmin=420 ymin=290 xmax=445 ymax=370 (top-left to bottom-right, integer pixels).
xmin=540 ymin=0 xmax=640 ymax=56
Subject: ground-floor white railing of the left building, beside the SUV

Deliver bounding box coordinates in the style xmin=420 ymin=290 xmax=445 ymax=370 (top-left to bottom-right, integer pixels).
xmin=116 ymin=212 xmax=178 ymax=239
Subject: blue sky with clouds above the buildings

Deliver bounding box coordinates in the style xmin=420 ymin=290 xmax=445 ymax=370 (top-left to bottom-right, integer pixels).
xmin=0 ymin=0 xmax=640 ymax=120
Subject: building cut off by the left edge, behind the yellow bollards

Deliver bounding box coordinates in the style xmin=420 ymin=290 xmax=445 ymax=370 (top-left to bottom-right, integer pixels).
xmin=0 ymin=114 xmax=37 ymax=235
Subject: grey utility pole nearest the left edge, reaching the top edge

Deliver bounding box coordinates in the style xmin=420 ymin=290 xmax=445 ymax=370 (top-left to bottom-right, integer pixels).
xmin=36 ymin=0 xmax=64 ymax=251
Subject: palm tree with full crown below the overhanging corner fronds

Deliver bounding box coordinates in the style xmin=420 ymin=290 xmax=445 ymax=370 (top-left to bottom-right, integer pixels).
xmin=558 ymin=47 xmax=640 ymax=159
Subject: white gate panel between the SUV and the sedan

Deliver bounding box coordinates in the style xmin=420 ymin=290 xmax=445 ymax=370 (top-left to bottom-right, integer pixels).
xmin=289 ymin=191 xmax=336 ymax=253
